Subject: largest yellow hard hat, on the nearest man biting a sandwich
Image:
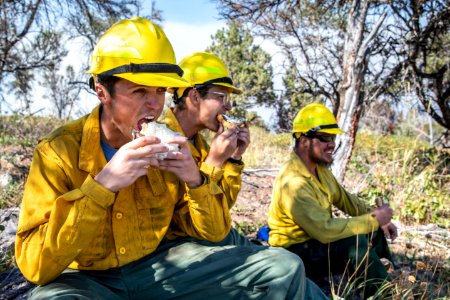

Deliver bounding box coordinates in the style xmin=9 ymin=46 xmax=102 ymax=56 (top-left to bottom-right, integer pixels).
xmin=87 ymin=17 xmax=189 ymax=87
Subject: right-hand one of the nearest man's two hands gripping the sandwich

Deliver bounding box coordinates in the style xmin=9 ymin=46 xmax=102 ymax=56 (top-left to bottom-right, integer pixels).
xmin=157 ymin=136 xmax=203 ymax=187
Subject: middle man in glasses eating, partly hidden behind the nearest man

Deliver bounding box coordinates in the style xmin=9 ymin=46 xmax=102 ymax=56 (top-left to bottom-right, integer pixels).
xmin=162 ymin=52 xmax=252 ymax=245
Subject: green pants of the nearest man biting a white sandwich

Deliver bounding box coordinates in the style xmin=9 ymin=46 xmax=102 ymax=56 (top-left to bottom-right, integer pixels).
xmin=30 ymin=231 xmax=327 ymax=300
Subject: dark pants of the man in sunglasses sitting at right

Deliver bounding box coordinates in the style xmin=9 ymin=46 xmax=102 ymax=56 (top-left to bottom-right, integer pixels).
xmin=287 ymin=230 xmax=392 ymax=298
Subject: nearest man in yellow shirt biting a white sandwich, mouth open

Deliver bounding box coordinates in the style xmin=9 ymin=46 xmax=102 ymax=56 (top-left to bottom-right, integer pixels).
xmin=15 ymin=17 xmax=324 ymax=300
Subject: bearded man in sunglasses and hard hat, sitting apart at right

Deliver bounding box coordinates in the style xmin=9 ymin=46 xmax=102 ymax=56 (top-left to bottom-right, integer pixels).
xmin=268 ymin=103 xmax=397 ymax=297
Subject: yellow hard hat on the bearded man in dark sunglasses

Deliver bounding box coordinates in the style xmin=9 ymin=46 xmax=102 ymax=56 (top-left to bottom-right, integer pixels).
xmin=292 ymin=103 xmax=344 ymax=134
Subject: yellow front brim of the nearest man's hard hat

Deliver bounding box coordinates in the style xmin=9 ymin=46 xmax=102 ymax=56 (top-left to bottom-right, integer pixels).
xmin=114 ymin=73 xmax=191 ymax=88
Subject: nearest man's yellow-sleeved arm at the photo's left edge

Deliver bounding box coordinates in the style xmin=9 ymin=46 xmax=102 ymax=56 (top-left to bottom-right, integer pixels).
xmin=15 ymin=143 xmax=115 ymax=284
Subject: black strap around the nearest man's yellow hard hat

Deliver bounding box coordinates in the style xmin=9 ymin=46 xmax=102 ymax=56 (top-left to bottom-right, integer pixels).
xmin=98 ymin=63 xmax=183 ymax=77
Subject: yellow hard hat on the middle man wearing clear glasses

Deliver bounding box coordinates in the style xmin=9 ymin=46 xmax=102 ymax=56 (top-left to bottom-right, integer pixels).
xmin=173 ymin=52 xmax=242 ymax=97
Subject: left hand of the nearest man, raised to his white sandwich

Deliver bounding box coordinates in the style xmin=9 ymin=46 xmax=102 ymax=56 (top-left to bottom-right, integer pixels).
xmin=95 ymin=136 xmax=168 ymax=192
